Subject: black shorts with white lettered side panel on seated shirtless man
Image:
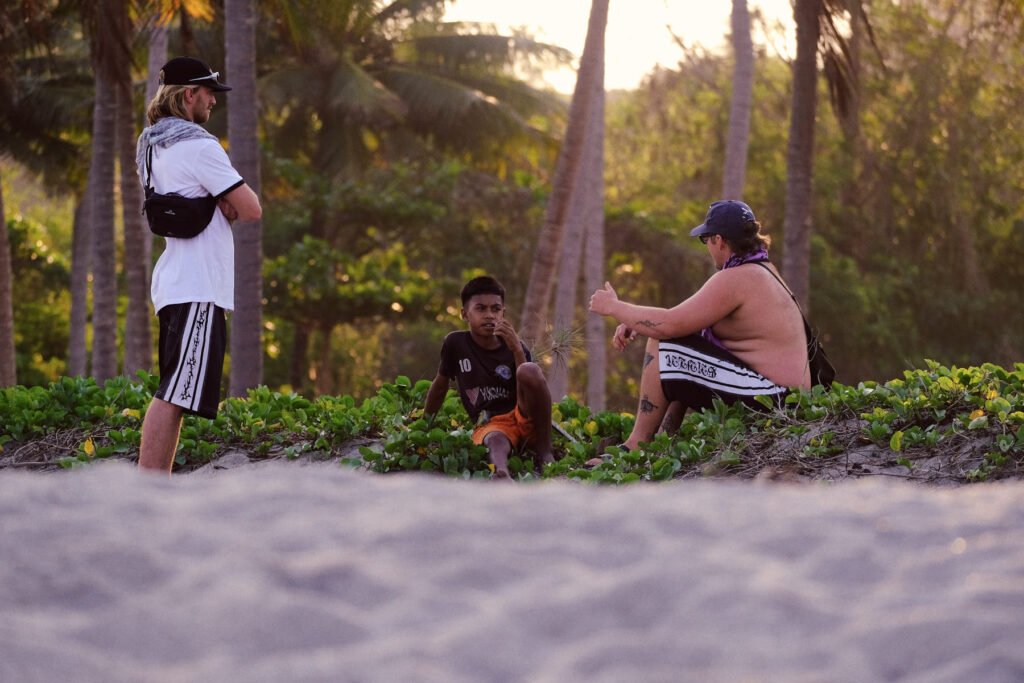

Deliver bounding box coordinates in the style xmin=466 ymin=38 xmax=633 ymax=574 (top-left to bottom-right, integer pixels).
xmin=657 ymin=335 xmax=790 ymax=411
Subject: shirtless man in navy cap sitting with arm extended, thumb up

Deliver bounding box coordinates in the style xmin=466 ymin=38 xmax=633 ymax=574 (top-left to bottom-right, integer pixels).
xmin=590 ymin=200 xmax=811 ymax=450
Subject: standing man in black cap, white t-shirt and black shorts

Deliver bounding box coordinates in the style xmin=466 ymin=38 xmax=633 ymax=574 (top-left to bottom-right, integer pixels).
xmin=135 ymin=57 xmax=262 ymax=473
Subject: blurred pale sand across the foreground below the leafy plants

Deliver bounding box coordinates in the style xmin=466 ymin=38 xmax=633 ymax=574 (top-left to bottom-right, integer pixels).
xmin=0 ymin=463 xmax=1024 ymax=683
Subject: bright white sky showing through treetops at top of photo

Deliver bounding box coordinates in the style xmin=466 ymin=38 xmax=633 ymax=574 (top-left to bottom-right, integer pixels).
xmin=444 ymin=0 xmax=793 ymax=92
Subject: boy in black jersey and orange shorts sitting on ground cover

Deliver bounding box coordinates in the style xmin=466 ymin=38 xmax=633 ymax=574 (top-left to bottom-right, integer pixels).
xmin=423 ymin=275 xmax=554 ymax=478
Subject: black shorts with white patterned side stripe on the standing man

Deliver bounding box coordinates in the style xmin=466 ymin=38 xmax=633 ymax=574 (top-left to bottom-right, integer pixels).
xmin=154 ymin=301 xmax=227 ymax=420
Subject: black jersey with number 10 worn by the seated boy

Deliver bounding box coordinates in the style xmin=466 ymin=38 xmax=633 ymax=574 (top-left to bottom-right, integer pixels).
xmin=437 ymin=331 xmax=532 ymax=423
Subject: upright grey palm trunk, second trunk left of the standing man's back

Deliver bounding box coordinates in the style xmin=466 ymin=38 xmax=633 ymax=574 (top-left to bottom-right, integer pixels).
xmin=89 ymin=64 xmax=118 ymax=382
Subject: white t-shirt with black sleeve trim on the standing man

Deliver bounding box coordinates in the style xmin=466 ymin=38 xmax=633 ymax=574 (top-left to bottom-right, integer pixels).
xmin=151 ymin=139 xmax=243 ymax=311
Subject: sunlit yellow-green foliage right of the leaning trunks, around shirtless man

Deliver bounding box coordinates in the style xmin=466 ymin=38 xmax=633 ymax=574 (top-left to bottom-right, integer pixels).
xmin=608 ymin=0 xmax=1024 ymax=382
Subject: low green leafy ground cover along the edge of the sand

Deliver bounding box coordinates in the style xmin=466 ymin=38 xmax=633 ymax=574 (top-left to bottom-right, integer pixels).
xmin=0 ymin=361 xmax=1024 ymax=484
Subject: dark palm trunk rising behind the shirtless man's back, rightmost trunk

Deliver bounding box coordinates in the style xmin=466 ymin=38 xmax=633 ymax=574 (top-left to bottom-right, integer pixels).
xmin=782 ymin=0 xmax=821 ymax=313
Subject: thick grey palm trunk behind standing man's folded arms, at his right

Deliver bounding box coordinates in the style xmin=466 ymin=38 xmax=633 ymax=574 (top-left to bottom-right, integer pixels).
xmin=224 ymin=0 xmax=263 ymax=396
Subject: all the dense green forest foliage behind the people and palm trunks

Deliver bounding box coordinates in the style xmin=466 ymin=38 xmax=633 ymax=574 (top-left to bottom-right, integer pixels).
xmin=0 ymin=0 xmax=1024 ymax=410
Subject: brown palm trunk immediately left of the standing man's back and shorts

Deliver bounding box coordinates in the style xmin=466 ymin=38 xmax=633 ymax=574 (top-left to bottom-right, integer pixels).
xmin=117 ymin=81 xmax=153 ymax=377
